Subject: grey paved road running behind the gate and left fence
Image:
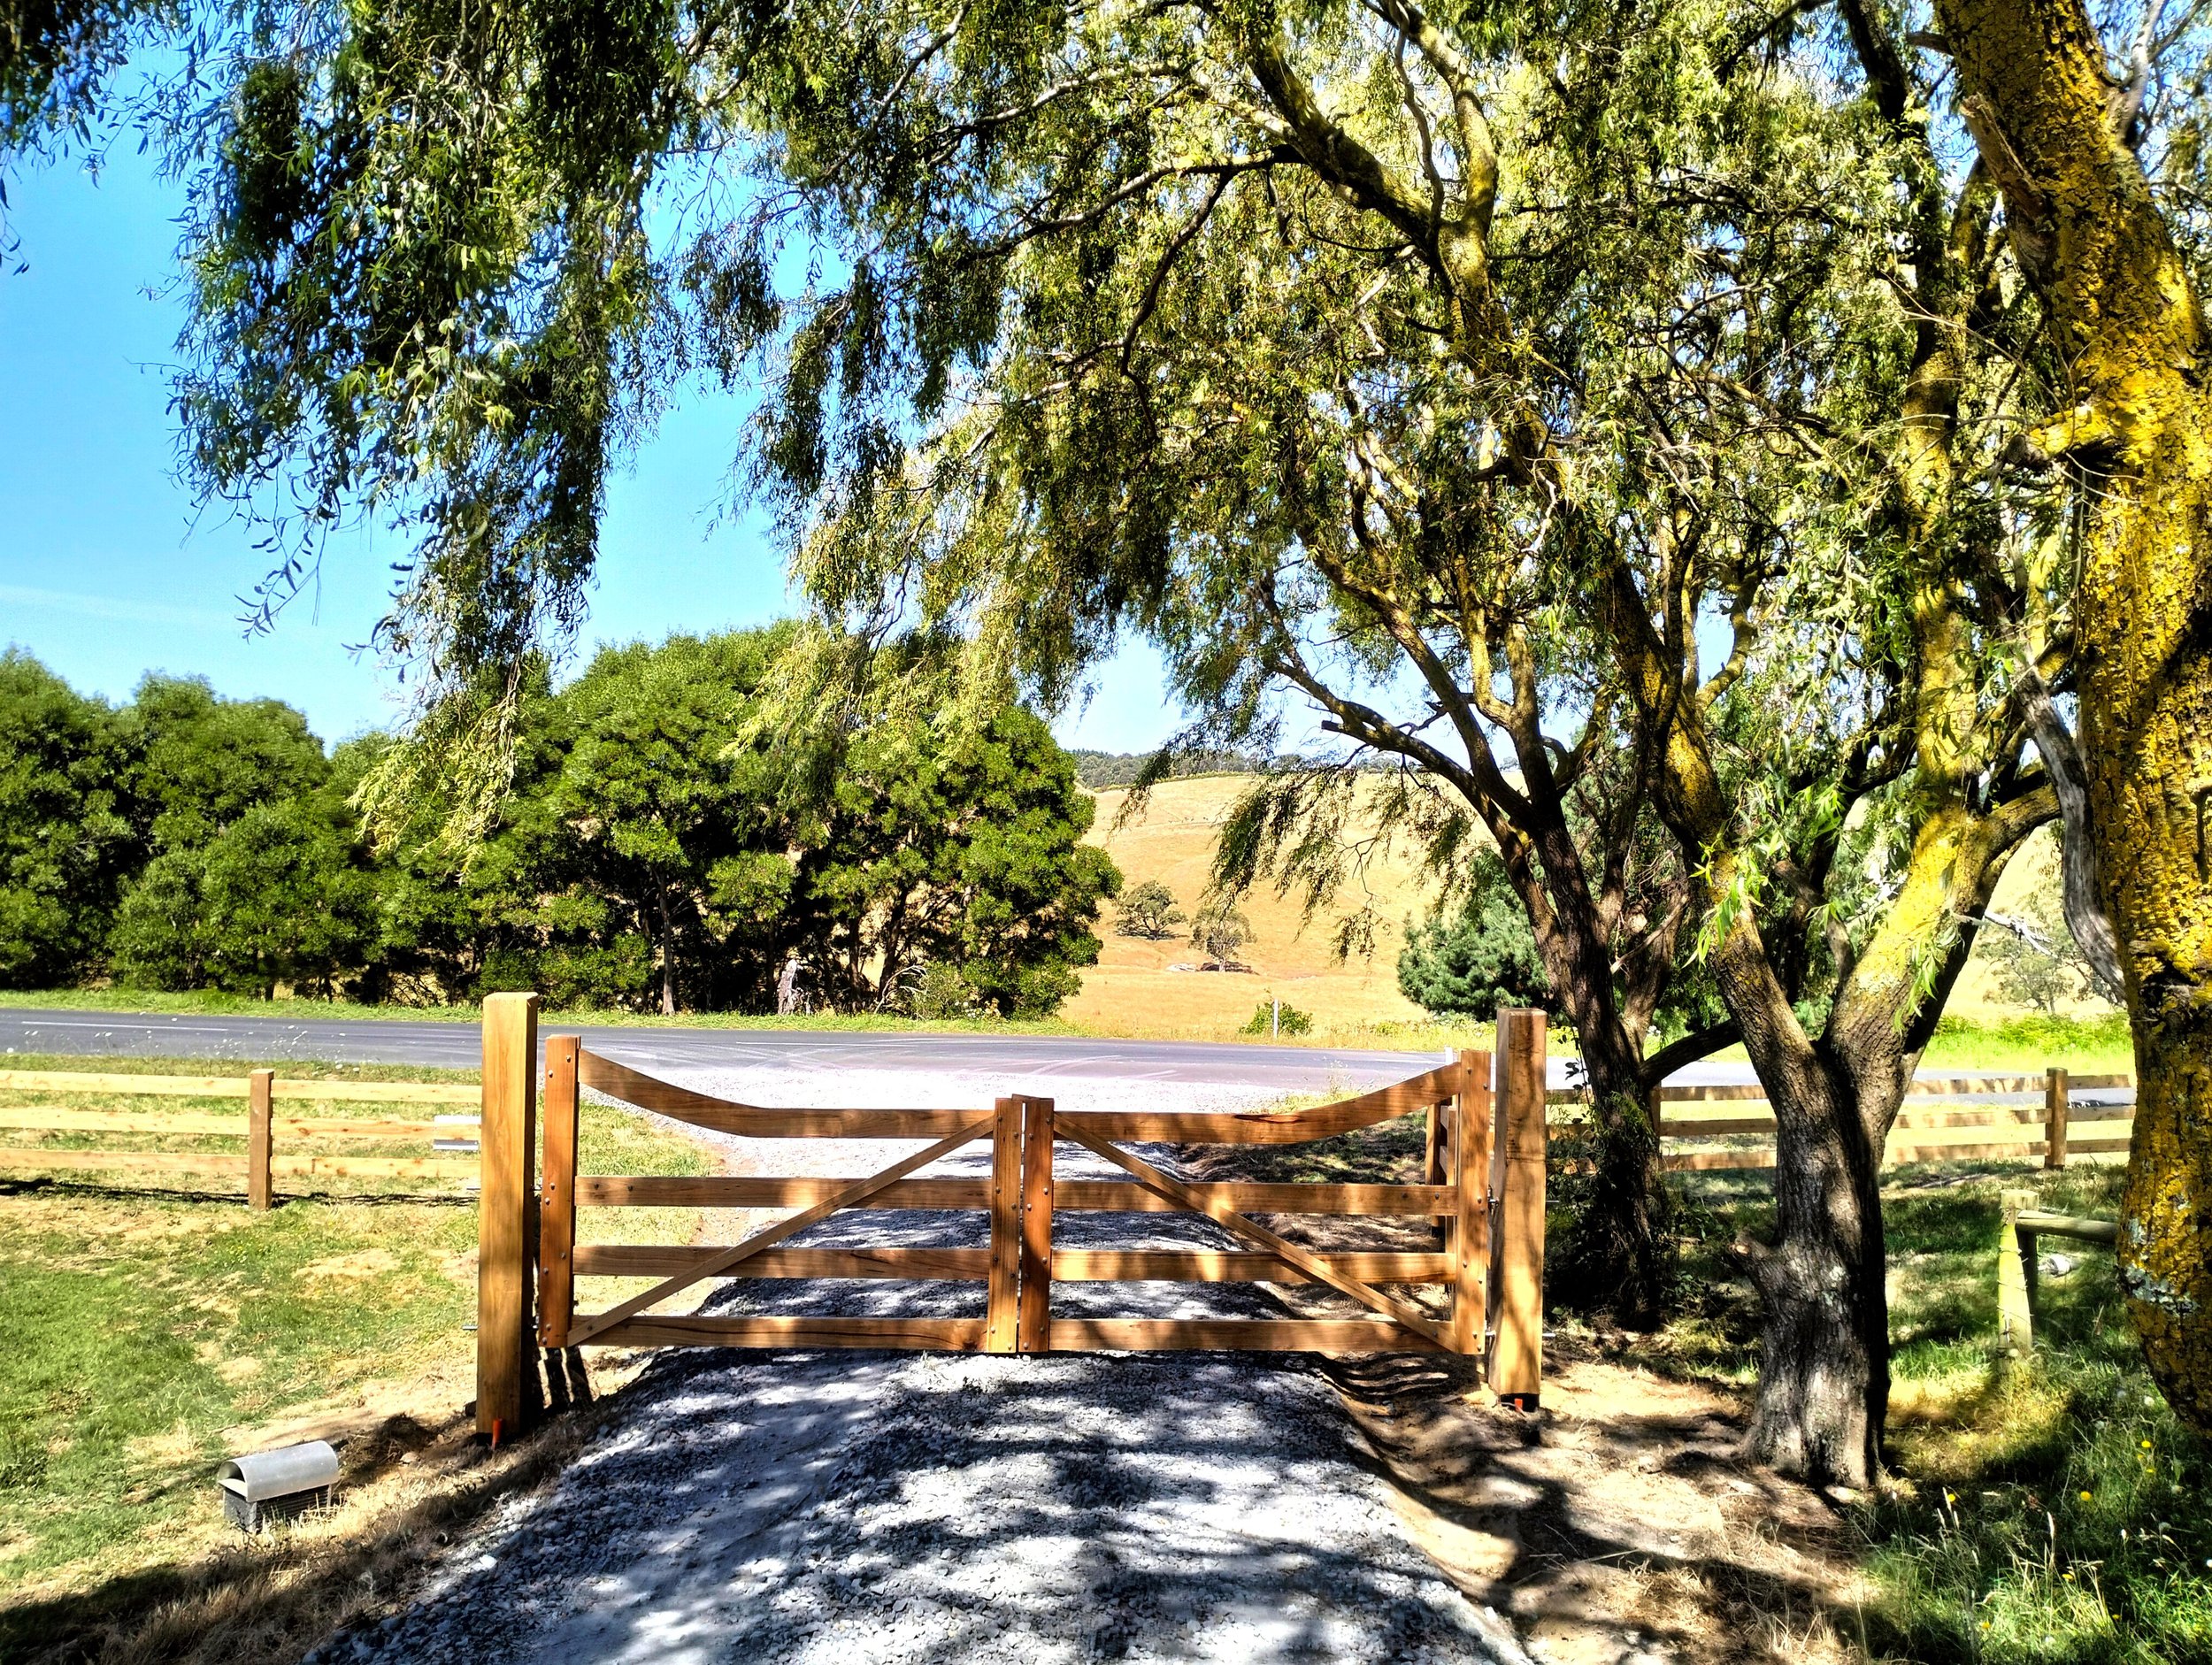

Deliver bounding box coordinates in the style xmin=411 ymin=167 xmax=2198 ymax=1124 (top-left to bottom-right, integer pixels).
xmin=0 ymin=1010 xmax=1478 ymax=1093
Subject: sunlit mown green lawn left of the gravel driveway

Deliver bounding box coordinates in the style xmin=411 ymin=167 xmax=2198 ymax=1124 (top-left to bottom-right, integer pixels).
xmin=0 ymin=1057 xmax=715 ymax=1656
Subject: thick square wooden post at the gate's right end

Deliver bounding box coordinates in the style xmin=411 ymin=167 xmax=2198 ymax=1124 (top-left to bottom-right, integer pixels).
xmin=1489 ymin=1006 xmax=1547 ymax=1411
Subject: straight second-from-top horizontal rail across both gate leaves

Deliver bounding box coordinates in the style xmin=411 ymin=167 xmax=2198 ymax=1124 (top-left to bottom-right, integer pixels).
xmin=575 ymin=1176 xmax=1454 ymax=1214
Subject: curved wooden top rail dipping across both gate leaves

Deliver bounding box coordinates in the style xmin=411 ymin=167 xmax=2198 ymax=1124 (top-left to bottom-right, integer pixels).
xmin=578 ymin=1048 xmax=1460 ymax=1146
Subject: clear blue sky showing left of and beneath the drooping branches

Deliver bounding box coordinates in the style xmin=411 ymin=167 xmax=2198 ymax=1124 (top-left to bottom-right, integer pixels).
xmin=0 ymin=143 xmax=1179 ymax=752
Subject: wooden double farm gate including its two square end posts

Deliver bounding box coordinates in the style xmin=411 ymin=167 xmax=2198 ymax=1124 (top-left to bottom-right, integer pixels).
xmin=476 ymin=995 xmax=1544 ymax=1438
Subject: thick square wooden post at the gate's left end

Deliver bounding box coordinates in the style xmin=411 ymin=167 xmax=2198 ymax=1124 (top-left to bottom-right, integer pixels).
xmin=476 ymin=995 xmax=538 ymax=1439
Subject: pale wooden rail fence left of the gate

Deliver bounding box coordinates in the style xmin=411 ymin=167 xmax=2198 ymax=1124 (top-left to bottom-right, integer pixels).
xmin=0 ymin=1070 xmax=482 ymax=1209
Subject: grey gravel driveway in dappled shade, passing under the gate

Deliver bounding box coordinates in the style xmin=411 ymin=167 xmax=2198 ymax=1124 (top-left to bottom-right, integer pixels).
xmin=314 ymin=1072 xmax=1526 ymax=1665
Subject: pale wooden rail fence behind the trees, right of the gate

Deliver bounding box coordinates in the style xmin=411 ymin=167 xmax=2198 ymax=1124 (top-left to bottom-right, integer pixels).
xmin=1551 ymin=1070 xmax=2135 ymax=1170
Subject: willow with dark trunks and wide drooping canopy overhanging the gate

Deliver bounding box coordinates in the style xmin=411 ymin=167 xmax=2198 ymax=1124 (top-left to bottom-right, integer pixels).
xmin=151 ymin=0 xmax=2088 ymax=1479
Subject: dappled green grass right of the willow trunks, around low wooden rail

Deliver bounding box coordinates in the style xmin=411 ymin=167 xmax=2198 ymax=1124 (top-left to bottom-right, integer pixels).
xmin=1637 ymin=1163 xmax=2212 ymax=1665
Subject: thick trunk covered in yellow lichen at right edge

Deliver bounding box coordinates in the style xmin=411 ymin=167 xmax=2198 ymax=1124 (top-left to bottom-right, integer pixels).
xmin=1938 ymin=0 xmax=2212 ymax=1433
